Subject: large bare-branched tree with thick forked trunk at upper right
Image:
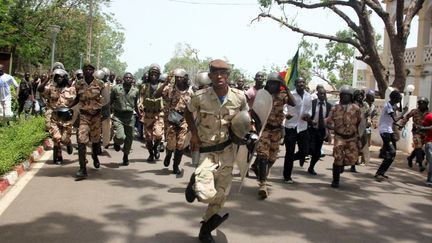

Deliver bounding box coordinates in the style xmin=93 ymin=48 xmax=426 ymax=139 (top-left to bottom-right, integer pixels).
xmin=258 ymin=0 xmax=425 ymax=97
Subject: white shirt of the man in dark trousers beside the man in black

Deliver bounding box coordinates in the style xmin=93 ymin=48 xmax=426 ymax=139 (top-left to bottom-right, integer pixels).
xmin=284 ymin=90 xmax=312 ymax=133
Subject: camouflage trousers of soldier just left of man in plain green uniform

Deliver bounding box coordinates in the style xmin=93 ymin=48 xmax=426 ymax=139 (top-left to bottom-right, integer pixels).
xmin=78 ymin=113 xmax=101 ymax=144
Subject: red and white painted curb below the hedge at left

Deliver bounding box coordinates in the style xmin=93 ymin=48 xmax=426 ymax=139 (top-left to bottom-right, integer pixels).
xmin=0 ymin=139 xmax=52 ymax=197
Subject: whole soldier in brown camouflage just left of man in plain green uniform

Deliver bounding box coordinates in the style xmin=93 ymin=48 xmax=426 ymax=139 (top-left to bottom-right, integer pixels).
xmin=70 ymin=64 xmax=104 ymax=180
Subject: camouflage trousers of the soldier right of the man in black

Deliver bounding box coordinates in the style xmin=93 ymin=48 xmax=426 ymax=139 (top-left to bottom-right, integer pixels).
xmin=333 ymin=135 xmax=359 ymax=166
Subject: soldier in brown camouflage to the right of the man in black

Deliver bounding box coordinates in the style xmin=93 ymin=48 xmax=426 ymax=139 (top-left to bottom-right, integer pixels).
xmin=326 ymin=85 xmax=361 ymax=188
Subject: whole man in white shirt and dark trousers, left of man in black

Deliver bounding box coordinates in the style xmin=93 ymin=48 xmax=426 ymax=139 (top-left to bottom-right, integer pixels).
xmin=283 ymin=77 xmax=312 ymax=183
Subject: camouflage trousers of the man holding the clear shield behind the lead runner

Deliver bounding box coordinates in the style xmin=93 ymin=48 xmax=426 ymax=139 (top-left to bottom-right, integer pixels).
xmin=257 ymin=128 xmax=282 ymax=162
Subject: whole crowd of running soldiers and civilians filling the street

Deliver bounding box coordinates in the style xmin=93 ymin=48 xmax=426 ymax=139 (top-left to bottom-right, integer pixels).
xmin=0 ymin=59 xmax=432 ymax=242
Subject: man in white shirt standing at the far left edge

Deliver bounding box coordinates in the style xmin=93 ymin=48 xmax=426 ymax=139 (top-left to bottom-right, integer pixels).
xmin=0 ymin=64 xmax=18 ymax=119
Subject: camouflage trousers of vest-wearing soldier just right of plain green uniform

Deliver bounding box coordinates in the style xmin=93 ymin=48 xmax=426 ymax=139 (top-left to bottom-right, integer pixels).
xmin=143 ymin=112 xmax=164 ymax=142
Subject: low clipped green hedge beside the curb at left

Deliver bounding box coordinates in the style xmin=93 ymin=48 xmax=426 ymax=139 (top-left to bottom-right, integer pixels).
xmin=0 ymin=117 xmax=48 ymax=175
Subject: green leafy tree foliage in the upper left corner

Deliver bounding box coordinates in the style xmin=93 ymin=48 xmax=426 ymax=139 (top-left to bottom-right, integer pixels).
xmin=0 ymin=0 xmax=126 ymax=74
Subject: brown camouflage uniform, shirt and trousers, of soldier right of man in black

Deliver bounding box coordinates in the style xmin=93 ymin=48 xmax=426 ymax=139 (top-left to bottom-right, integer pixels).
xmin=327 ymin=104 xmax=361 ymax=166
